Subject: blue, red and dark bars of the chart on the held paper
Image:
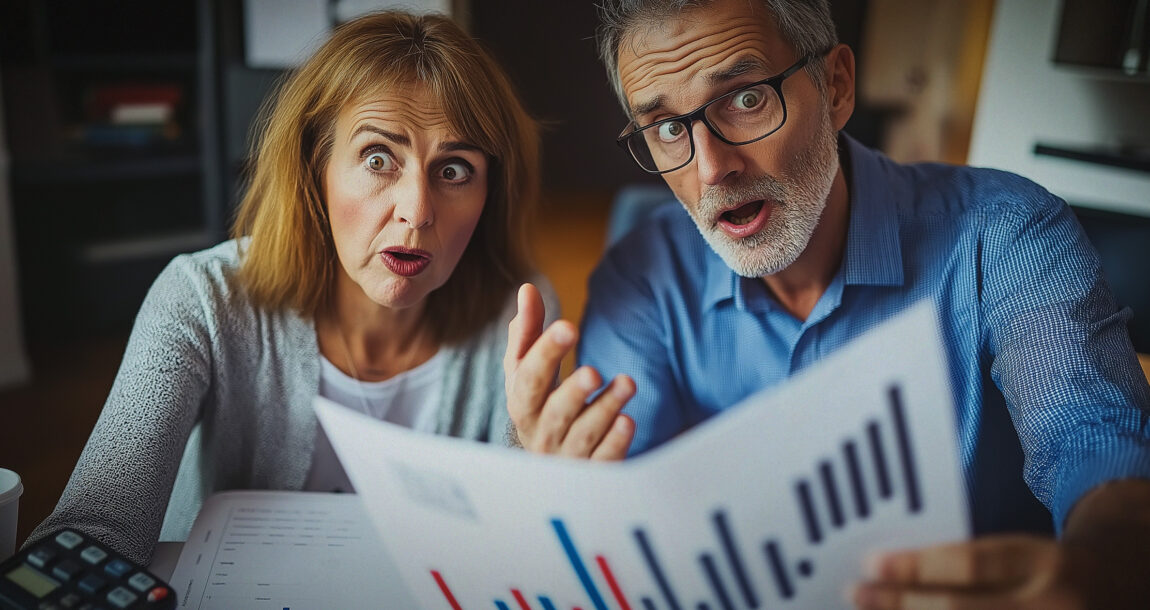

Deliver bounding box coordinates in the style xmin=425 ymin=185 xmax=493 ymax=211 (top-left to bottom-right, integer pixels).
xmin=430 ymin=384 xmax=923 ymax=610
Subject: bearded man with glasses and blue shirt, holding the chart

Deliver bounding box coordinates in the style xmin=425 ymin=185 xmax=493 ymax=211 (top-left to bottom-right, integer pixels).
xmin=505 ymin=0 xmax=1150 ymax=609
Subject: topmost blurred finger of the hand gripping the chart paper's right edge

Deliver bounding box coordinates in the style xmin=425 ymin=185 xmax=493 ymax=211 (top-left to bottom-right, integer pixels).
xmin=872 ymin=536 xmax=1055 ymax=587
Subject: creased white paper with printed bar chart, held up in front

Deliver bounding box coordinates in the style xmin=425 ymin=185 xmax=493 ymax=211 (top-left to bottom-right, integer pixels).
xmin=316 ymin=305 xmax=968 ymax=610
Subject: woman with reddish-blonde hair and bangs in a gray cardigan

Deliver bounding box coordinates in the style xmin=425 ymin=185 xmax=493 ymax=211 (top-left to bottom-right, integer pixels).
xmin=23 ymin=13 xmax=551 ymax=563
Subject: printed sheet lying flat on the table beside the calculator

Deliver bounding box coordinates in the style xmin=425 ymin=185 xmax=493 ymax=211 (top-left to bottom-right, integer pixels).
xmin=169 ymin=491 xmax=419 ymax=610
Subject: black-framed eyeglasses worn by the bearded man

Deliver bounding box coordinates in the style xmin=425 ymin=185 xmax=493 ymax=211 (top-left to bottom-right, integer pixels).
xmin=615 ymin=55 xmax=814 ymax=174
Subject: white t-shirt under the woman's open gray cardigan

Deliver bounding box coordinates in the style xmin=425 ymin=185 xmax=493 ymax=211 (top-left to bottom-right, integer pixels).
xmin=304 ymin=351 xmax=444 ymax=493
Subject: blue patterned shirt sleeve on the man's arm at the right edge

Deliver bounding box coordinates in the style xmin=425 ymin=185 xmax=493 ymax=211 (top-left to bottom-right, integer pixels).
xmin=980 ymin=185 xmax=1150 ymax=532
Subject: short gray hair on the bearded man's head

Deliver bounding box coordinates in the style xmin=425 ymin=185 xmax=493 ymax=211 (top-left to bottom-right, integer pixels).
xmin=596 ymin=0 xmax=838 ymax=116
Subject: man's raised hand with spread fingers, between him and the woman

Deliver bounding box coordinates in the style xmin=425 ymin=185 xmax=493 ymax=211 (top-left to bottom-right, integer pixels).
xmin=504 ymin=284 xmax=635 ymax=459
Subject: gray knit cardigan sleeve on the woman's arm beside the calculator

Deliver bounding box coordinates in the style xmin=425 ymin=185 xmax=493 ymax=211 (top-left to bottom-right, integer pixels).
xmin=29 ymin=257 xmax=215 ymax=564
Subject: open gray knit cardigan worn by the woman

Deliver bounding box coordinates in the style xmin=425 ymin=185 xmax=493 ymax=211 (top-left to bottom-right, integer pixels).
xmin=29 ymin=241 xmax=558 ymax=563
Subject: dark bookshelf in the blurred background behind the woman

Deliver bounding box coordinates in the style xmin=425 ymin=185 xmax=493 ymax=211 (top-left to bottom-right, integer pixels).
xmin=0 ymin=0 xmax=230 ymax=341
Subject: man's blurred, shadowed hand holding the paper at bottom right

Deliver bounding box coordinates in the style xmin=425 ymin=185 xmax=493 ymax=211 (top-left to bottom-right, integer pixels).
xmin=852 ymin=480 xmax=1150 ymax=610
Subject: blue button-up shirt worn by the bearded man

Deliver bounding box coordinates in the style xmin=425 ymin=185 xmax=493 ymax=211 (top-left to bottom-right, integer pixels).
xmin=578 ymin=137 xmax=1150 ymax=533
